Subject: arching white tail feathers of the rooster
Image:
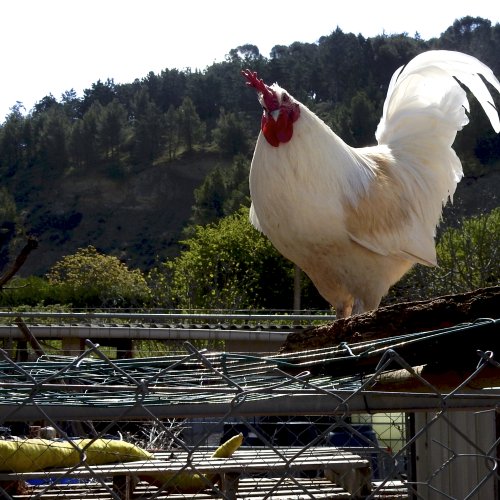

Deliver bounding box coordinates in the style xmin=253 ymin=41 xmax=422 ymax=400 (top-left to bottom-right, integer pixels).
xmin=376 ymin=50 xmax=500 ymax=227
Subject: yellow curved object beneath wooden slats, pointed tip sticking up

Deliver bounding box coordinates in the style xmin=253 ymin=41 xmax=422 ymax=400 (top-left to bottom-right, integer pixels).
xmin=139 ymin=432 xmax=243 ymax=493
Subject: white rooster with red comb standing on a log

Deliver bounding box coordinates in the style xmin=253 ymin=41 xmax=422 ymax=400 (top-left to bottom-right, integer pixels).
xmin=243 ymin=51 xmax=500 ymax=317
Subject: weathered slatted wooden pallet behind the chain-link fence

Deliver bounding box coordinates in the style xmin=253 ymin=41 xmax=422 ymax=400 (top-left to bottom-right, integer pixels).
xmin=0 ymin=447 xmax=371 ymax=500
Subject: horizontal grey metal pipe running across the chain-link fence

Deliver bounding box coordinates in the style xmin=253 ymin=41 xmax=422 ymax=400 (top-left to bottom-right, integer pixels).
xmin=0 ymin=390 xmax=500 ymax=421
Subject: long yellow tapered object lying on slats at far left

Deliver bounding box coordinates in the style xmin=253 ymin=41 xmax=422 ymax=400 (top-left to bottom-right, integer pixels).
xmin=0 ymin=439 xmax=154 ymax=472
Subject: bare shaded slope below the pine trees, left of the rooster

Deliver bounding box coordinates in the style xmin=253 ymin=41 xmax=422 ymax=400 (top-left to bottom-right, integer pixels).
xmin=13 ymin=154 xmax=223 ymax=275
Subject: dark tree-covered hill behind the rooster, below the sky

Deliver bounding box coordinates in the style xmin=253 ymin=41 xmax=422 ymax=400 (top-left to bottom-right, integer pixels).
xmin=0 ymin=17 xmax=500 ymax=280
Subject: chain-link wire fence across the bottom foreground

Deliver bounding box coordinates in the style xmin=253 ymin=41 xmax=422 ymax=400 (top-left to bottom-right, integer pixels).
xmin=0 ymin=326 xmax=500 ymax=500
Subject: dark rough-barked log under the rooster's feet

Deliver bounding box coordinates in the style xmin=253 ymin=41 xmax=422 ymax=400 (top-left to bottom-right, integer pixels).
xmin=281 ymin=287 xmax=500 ymax=382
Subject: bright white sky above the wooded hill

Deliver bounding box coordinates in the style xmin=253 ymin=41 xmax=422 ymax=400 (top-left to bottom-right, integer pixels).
xmin=0 ymin=0 xmax=500 ymax=122
